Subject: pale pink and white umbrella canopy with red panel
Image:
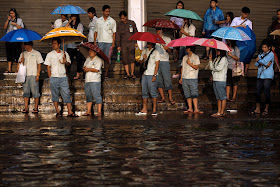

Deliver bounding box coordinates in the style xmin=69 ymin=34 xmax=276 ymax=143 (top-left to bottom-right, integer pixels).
xmin=193 ymin=38 xmax=231 ymax=51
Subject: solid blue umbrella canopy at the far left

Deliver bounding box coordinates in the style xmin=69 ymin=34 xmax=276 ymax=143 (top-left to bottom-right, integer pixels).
xmin=0 ymin=29 xmax=42 ymax=42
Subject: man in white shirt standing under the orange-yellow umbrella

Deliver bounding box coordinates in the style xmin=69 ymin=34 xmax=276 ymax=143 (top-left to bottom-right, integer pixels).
xmin=44 ymin=38 xmax=78 ymax=117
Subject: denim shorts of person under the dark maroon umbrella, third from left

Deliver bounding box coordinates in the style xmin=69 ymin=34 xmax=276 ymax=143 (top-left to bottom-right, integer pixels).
xmin=85 ymin=82 xmax=102 ymax=104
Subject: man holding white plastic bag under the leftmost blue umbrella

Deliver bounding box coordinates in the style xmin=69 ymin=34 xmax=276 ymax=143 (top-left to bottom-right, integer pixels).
xmin=18 ymin=42 xmax=44 ymax=113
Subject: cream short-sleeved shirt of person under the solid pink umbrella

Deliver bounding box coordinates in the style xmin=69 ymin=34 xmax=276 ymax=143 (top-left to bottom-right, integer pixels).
xmin=182 ymin=53 xmax=200 ymax=79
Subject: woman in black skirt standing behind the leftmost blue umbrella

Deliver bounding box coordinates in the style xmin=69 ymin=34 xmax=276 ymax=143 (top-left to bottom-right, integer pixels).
xmin=4 ymin=8 xmax=24 ymax=73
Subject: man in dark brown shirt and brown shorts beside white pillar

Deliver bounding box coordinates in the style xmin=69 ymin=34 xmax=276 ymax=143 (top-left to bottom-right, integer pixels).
xmin=116 ymin=11 xmax=138 ymax=79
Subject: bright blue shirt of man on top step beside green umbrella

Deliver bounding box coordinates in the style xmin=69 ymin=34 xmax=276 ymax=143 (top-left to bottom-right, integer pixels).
xmin=202 ymin=7 xmax=225 ymax=32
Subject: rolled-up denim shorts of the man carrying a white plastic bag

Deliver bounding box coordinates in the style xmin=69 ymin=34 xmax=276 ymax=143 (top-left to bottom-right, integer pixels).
xmin=22 ymin=76 xmax=40 ymax=98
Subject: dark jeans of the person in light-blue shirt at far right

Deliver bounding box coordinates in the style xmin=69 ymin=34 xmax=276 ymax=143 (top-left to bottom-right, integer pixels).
xmin=256 ymin=79 xmax=272 ymax=104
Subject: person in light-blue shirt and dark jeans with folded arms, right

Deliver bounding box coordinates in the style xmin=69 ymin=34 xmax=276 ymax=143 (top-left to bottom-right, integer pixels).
xmin=253 ymin=39 xmax=274 ymax=115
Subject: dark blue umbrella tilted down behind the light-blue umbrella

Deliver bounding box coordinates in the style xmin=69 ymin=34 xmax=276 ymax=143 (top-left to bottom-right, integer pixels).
xmin=236 ymin=26 xmax=256 ymax=64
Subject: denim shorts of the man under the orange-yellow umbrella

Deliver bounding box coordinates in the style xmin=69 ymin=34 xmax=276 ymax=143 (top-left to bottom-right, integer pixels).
xmin=50 ymin=77 xmax=71 ymax=103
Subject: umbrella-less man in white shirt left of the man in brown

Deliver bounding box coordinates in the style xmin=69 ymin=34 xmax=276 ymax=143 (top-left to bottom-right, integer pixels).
xmin=94 ymin=5 xmax=117 ymax=78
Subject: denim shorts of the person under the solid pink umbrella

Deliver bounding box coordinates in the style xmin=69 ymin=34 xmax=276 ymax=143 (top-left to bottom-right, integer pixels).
xmin=182 ymin=79 xmax=198 ymax=99
